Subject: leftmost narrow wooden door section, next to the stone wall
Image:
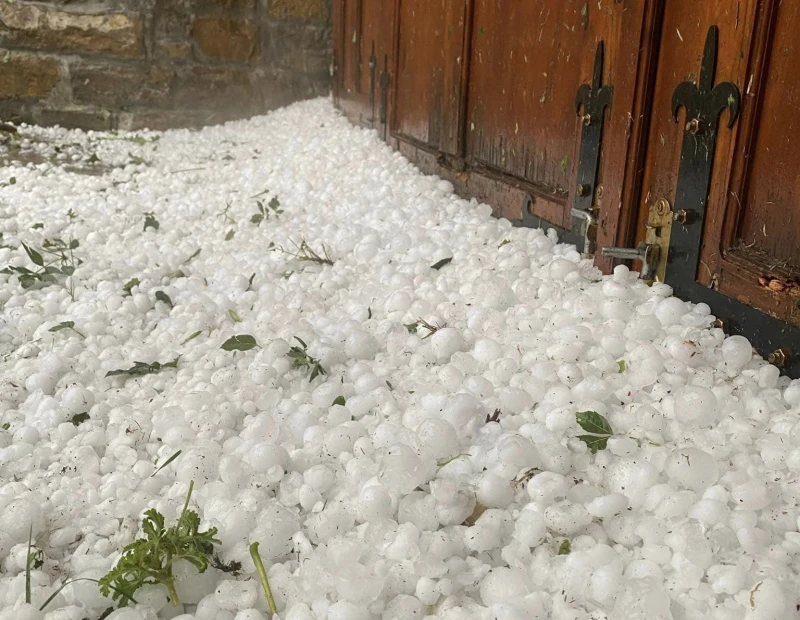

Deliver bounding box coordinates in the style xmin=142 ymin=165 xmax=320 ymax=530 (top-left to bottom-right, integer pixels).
xmin=332 ymin=0 xmax=395 ymax=128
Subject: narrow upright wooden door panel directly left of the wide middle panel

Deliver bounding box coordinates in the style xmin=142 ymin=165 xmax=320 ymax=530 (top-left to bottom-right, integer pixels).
xmin=393 ymin=0 xmax=468 ymax=155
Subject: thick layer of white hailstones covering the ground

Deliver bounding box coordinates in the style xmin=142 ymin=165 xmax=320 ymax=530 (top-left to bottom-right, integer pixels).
xmin=0 ymin=100 xmax=800 ymax=620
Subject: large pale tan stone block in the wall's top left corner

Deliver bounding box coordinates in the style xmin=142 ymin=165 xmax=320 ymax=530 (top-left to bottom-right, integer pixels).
xmin=0 ymin=1 xmax=144 ymax=58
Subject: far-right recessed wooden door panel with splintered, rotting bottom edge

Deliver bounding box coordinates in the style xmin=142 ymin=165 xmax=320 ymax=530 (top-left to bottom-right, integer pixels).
xmin=706 ymin=0 xmax=800 ymax=326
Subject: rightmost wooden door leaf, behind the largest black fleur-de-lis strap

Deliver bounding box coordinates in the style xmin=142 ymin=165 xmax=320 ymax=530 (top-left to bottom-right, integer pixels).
xmin=618 ymin=0 xmax=800 ymax=372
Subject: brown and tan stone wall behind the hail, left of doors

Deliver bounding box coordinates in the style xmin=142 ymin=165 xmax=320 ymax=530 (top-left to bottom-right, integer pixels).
xmin=0 ymin=0 xmax=331 ymax=129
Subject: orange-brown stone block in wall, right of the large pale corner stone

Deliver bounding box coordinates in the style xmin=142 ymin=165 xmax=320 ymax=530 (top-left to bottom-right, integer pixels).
xmin=192 ymin=17 xmax=260 ymax=63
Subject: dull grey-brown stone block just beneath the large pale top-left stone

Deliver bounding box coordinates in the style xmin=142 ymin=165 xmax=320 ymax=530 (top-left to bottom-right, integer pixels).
xmin=70 ymin=63 xmax=175 ymax=110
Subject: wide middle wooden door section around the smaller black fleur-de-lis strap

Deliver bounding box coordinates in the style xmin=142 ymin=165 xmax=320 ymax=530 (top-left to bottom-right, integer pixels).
xmin=467 ymin=0 xmax=657 ymax=236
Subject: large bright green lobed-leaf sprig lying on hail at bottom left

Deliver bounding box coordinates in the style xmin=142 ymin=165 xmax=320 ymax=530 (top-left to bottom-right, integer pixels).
xmin=99 ymin=481 xmax=222 ymax=607
